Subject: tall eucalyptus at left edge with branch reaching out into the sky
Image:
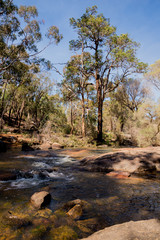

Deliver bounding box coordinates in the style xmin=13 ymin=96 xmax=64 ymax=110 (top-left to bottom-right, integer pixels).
xmin=0 ymin=0 xmax=63 ymax=127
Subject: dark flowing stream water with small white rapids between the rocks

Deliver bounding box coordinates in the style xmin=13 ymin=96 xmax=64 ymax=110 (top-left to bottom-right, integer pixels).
xmin=0 ymin=150 xmax=160 ymax=229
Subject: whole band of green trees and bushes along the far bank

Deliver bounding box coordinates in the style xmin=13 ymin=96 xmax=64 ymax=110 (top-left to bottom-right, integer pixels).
xmin=0 ymin=0 xmax=156 ymax=147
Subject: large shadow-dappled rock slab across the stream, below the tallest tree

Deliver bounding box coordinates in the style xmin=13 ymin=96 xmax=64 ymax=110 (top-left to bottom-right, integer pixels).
xmin=80 ymin=147 xmax=160 ymax=178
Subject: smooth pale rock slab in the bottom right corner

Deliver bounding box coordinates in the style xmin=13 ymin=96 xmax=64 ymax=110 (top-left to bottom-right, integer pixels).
xmin=83 ymin=219 xmax=160 ymax=240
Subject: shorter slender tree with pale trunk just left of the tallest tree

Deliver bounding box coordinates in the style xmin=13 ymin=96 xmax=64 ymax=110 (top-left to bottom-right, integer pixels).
xmin=62 ymin=52 xmax=92 ymax=137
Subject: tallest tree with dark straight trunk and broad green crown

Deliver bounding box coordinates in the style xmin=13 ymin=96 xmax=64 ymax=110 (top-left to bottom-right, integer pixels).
xmin=70 ymin=6 xmax=146 ymax=142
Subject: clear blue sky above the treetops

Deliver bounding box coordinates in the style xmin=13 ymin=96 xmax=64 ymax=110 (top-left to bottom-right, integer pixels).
xmin=13 ymin=0 xmax=160 ymax=93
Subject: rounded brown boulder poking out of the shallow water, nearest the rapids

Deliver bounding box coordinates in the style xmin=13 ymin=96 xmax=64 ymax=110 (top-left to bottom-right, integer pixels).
xmin=31 ymin=191 xmax=51 ymax=209
